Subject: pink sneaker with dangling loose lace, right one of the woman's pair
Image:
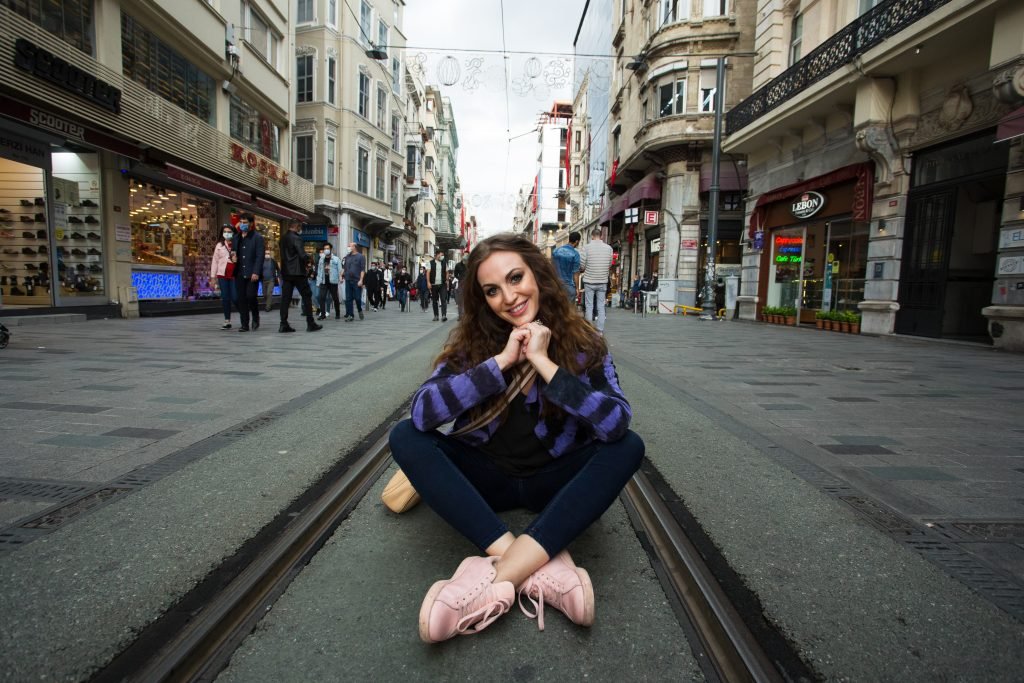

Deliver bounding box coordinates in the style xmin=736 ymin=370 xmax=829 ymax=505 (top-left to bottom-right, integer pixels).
xmin=519 ymin=550 xmax=594 ymax=631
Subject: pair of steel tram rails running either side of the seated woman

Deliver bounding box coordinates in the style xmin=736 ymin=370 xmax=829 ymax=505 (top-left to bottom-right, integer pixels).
xmin=92 ymin=417 xmax=791 ymax=683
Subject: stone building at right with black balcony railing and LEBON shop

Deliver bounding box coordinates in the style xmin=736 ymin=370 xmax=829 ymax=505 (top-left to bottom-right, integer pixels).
xmin=724 ymin=0 xmax=1024 ymax=350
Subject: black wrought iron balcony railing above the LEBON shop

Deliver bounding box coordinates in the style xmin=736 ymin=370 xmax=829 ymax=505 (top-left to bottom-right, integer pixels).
xmin=725 ymin=0 xmax=951 ymax=133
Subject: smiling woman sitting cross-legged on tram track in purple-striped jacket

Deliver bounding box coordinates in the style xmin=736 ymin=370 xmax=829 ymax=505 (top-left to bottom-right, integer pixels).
xmin=389 ymin=233 xmax=644 ymax=643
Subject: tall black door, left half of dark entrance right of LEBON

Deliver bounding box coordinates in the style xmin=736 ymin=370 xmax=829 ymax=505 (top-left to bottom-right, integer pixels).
xmin=895 ymin=189 xmax=956 ymax=337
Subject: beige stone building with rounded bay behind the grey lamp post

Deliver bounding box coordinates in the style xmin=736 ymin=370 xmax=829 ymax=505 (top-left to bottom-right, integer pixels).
xmin=584 ymin=0 xmax=756 ymax=313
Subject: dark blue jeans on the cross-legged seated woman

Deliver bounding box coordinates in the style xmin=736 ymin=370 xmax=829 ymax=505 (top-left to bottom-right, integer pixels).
xmin=389 ymin=420 xmax=644 ymax=557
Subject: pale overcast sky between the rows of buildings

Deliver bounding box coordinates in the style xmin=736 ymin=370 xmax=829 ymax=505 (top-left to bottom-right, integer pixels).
xmin=403 ymin=0 xmax=586 ymax=237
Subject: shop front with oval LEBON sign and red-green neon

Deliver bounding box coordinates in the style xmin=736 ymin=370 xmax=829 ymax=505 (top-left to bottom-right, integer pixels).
xmin=751 ymin=165 xmax=871 ymax=324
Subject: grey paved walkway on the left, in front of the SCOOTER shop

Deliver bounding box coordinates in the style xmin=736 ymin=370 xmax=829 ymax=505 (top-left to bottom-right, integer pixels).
xmin=0 ymin=305 xmax=451 ymax=527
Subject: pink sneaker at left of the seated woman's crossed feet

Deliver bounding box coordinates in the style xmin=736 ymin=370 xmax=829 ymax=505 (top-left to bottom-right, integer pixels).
xmin=420 ymin=557 xmax=515 ymax=643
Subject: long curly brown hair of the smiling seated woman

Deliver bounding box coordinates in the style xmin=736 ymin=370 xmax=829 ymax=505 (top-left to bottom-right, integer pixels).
xmin=434 ymin=232 xmax=607 ymax=375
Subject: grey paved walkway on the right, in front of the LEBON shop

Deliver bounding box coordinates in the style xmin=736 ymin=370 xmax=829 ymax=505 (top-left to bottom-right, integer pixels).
xmin=607 ymin=311 xmax=1024 ymax=610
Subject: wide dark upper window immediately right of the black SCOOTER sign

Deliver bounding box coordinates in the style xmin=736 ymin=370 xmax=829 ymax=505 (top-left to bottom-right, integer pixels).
xmin=121 ymin=12 xmax=216 ymax=125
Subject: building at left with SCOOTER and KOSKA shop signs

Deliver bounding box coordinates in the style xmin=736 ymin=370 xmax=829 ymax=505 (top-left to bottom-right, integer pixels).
xmin=0 ymin=0 xmax=313 ymax=316
